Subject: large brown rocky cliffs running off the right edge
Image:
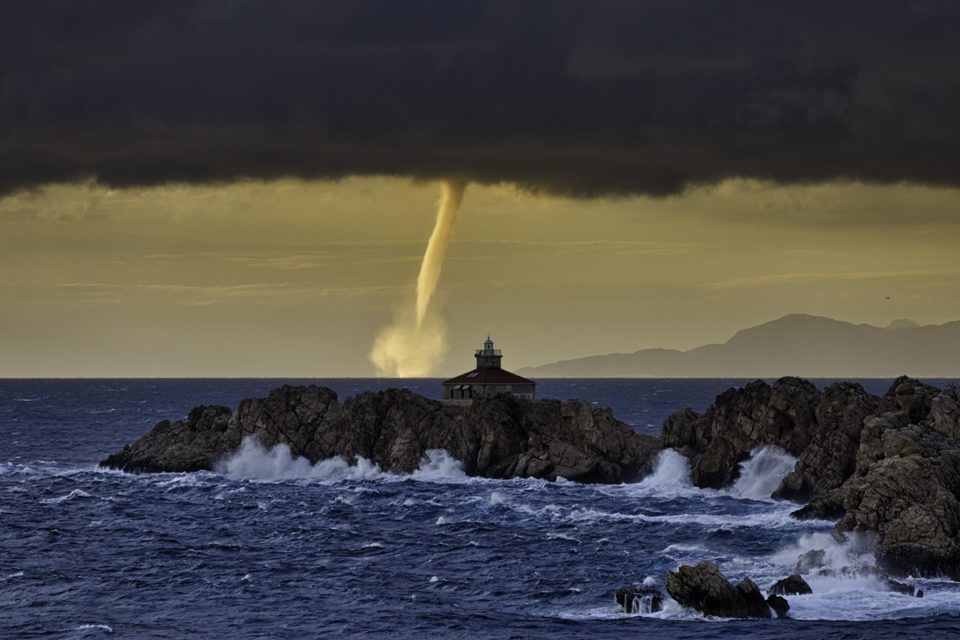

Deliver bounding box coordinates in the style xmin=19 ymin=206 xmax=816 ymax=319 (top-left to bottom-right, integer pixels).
xmin=663 ymin=377 xmax=960 ymax=579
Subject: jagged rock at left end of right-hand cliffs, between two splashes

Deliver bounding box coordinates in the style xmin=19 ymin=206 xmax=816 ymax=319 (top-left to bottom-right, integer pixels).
xmin=662 ymin=378 xmax=819 ymax=488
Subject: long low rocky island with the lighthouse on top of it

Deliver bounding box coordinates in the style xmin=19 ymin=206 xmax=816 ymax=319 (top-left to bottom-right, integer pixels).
xmin=101 ymin=386 xmax=660 ymax=482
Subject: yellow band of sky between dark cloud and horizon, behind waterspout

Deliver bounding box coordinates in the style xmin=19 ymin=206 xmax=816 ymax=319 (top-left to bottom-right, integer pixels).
xmin=0 ymin=178 xmax=960 ymax=377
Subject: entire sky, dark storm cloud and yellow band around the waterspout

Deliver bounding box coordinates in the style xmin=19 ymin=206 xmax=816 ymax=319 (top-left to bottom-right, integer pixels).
xmin=0 ymin=0 xmax=960 ymax=377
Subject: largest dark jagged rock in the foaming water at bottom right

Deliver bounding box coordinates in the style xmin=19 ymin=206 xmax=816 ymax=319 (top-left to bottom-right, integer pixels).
xmin=667 ymin=561 xmax=770 ymax=618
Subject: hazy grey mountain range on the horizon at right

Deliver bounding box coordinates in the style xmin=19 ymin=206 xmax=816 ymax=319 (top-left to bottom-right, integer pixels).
xmin=517 ymin=314 xmax=960 ymax=378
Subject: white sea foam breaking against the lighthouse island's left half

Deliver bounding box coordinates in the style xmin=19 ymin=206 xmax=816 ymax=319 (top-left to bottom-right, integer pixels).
xmin=216 ymin=436 xmax=476 ymax=483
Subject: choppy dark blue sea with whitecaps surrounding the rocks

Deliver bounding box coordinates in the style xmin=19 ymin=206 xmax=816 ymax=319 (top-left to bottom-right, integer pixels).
xmin=0 ymin=379 xmax=960 ymax=640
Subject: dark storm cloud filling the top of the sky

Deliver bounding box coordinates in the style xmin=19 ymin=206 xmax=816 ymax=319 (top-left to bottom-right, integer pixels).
xmin=0 ymin=0 xmax=960 ymax=196
